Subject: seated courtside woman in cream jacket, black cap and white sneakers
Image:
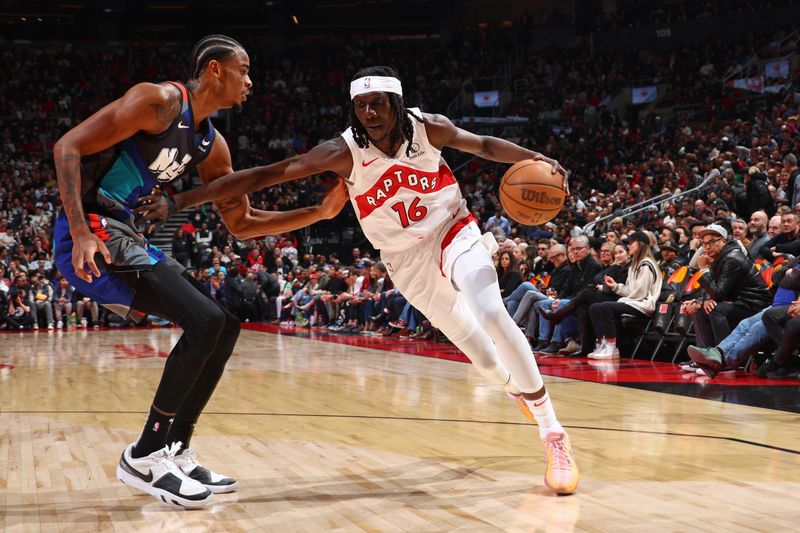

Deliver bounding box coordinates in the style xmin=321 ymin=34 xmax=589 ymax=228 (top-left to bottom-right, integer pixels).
xmin=588 ymin=231 xmax=661 ymax=359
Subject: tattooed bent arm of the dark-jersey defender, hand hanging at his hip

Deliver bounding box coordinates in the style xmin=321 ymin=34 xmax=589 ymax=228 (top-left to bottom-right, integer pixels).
xmin=53 ymin=83 xmax=181 ymax=283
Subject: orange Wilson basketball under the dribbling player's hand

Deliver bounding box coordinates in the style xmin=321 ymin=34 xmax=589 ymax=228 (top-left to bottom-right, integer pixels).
xmin=500 ymin=159 xmax=566 ymax=226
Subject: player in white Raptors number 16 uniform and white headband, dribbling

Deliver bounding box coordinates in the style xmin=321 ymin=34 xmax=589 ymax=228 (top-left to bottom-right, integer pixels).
xmin=143 ymin=67 xmax=579 ymax=494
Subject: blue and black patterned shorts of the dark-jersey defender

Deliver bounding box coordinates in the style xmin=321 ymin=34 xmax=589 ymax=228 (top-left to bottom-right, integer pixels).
xmin=53 ymin=211 xmax=185 ymax=320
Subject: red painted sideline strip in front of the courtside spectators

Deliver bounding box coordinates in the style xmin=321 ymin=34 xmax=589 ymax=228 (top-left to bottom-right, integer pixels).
xmin=242 ymin=323 xmax=800 ymax=387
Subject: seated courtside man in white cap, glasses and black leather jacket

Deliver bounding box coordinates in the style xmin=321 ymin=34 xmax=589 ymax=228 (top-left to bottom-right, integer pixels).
xmin=681 ymin=224 xmax=771 ymax=347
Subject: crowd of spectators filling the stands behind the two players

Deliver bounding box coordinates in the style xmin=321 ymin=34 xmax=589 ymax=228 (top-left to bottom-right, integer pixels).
xmin=0 ymin=0 xmax=800 ymax=374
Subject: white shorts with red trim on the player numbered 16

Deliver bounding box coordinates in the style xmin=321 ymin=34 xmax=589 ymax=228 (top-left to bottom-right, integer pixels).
xmin=381 ymin=222 xmax=498 ymax=340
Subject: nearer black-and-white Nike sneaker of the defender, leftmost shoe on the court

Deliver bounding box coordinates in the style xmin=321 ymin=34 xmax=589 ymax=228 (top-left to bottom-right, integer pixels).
xmin=117 ymin=442 xmax=212 ymax=509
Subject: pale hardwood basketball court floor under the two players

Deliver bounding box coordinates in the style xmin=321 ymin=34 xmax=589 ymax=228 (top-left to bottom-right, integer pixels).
xmin=0 ymin=327 xmax=800 ymax=533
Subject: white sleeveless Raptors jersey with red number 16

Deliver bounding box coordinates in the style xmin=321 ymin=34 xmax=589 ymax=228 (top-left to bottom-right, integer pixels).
xmin=342 ymin=108 xmax=469 ymax=251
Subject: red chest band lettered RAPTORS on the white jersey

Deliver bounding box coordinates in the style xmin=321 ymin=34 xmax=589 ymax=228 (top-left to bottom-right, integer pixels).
xmin=356 ymin=165 xmax=456 ymax=218
